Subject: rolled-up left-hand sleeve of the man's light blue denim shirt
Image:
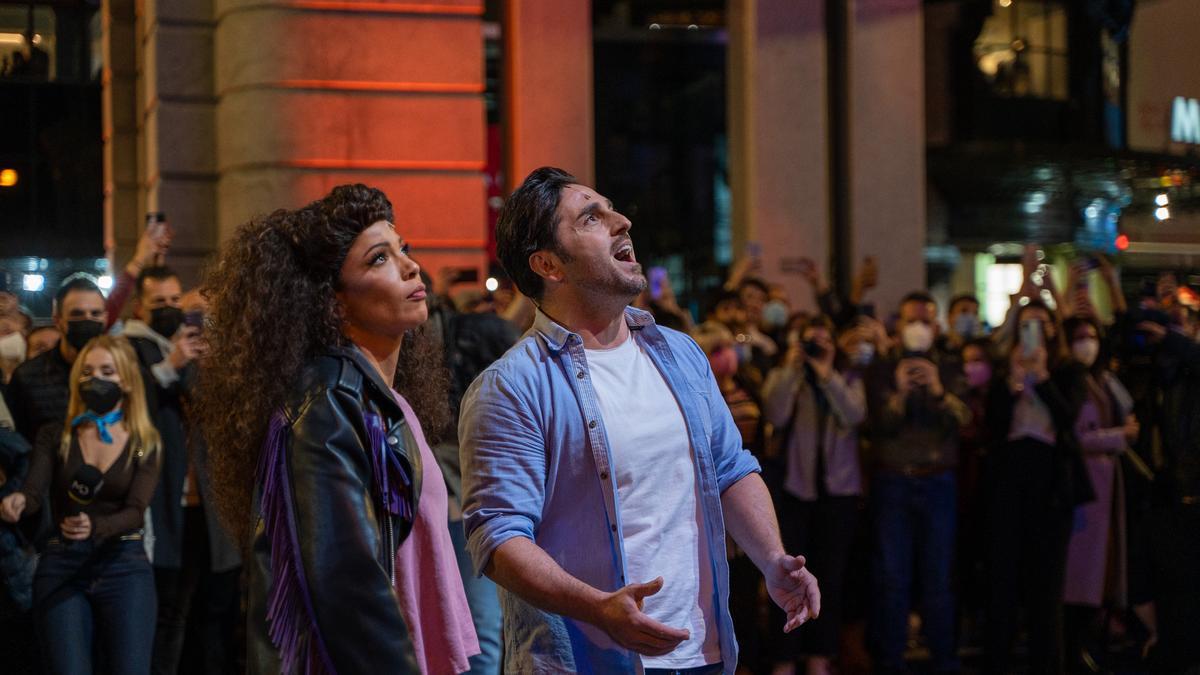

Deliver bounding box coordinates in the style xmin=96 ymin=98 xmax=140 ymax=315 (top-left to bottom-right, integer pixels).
xmin=458 ymin=371 xmax=546 ymax=575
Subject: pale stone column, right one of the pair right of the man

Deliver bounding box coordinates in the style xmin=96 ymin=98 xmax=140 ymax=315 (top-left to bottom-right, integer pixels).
xmin=847 ymin=0 xmax=926 ymax=318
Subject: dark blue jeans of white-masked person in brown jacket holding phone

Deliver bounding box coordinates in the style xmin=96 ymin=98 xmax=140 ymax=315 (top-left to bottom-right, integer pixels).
xmin=871 ymin=471 xmax=960 ymax=670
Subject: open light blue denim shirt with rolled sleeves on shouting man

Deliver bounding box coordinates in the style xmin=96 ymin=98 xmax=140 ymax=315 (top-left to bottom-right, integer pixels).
xmin=458 ymin=307 xmax=758 ymax=675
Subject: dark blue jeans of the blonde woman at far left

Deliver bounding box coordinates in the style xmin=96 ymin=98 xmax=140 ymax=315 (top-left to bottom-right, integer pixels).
xmin=34 ymin=539 xmax=156 ymax=674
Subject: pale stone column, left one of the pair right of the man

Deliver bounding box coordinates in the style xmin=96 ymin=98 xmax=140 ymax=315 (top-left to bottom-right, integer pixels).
xmin=728 ymin=0 xmax=830 ymax=310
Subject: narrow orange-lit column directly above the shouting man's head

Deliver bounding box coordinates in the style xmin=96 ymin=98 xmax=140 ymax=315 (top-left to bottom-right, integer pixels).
xmin=502 ymin=0 xmax=592 ymax=186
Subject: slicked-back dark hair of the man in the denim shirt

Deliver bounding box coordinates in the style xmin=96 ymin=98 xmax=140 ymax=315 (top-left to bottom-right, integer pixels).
xmin=496 ymin=167 xmax=578 ymax=300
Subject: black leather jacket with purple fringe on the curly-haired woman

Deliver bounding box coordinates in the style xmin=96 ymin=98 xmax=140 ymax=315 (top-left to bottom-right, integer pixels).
xmin=247 ymin=347 xmax=421 ymax=674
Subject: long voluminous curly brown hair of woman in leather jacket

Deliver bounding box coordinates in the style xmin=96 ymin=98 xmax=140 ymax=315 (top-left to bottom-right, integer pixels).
xmin=193 ymin=185 xmax=449 ymax=545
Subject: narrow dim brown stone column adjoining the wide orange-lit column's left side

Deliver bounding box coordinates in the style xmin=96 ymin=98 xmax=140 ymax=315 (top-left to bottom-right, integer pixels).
xmin=139 ymin=0 xmax=217 ymax=288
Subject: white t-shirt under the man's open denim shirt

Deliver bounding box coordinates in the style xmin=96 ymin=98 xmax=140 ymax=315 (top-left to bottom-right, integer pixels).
xmin=587 ymin=336 xmax=722 ymax=669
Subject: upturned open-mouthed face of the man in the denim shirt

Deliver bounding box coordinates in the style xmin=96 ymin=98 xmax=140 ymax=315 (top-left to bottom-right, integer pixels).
xmin=556 ymin=184 xmax=646 ymax=301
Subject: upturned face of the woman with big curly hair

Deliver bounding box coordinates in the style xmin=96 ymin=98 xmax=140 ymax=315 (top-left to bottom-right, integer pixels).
xmin=337 ymin=221 xmax=428 ymax=338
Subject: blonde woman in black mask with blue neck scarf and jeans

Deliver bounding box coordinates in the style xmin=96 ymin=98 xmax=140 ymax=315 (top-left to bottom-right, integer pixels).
xmin=0 ymin=335 xmax=160 ymax=673
